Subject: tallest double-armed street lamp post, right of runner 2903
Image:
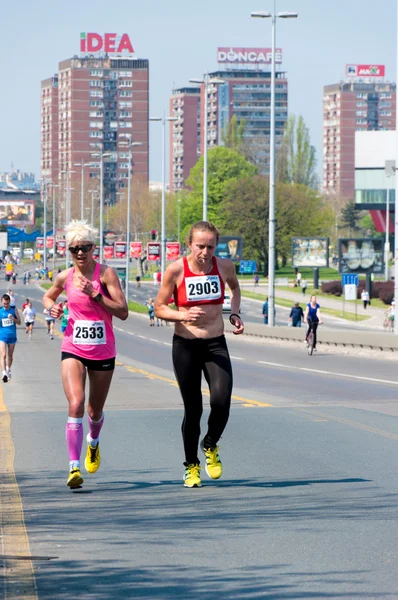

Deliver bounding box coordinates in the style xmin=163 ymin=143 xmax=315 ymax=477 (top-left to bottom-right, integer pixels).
xmin=251 ymin=0 xmax=298 ymax=327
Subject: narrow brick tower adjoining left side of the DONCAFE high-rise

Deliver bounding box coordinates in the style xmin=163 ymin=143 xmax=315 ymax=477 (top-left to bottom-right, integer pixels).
xmin=170 ymin=86 xmax=200 ymax=191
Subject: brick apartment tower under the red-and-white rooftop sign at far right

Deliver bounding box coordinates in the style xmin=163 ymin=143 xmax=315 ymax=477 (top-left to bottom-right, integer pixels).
xmin=322 ymin=81 xmax=396 ymax=199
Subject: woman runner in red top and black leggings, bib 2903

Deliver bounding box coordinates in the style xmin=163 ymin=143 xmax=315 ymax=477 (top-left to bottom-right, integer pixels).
xmin=155 ymin=221 xmax=244 ymax=487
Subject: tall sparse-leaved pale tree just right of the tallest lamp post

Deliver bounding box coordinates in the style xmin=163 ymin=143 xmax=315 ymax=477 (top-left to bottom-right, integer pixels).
xmin=276 ymin=115 xmax=318 ymax=189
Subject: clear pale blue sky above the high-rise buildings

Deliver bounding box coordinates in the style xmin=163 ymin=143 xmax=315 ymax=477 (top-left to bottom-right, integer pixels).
xmin=0 ymin=0 xmax=397 ymax=180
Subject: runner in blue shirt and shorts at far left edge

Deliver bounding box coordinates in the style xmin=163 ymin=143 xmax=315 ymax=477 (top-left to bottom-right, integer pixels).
xmin=0 ymin=294 xmax=21 ymax=383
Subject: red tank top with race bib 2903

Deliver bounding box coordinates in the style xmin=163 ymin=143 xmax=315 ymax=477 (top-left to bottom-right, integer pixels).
xmin=174 ymin=256 xmax=225 ymax=308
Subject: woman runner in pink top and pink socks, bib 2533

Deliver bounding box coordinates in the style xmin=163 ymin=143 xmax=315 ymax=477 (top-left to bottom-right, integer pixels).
xmin=43 ymin=221 xmax=128 ymax=489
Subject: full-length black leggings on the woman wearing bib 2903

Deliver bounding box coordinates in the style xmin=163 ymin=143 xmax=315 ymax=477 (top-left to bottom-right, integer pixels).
xmin=173 ymin=335 xmax=232 ymax=464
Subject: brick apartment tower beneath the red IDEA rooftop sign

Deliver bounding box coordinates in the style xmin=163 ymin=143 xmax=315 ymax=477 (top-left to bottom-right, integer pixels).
xmin=41 ymin=56 xmax=149 ymax=209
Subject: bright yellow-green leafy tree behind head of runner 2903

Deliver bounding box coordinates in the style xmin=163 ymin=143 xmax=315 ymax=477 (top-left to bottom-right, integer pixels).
xmin=181 ymin=146 xmax=256 ymax=235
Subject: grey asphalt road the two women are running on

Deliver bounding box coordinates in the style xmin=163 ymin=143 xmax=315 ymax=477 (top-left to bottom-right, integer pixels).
xmin=0 ymin=287 xmax=398 ymax=600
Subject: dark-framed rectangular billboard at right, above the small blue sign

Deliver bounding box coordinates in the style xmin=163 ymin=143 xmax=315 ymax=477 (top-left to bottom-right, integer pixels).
xmin=339 ymin=238 xmax=384 ymax=275
